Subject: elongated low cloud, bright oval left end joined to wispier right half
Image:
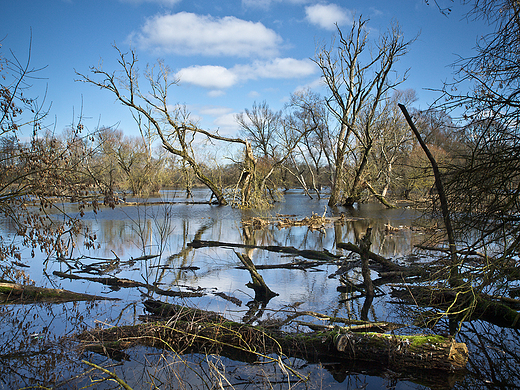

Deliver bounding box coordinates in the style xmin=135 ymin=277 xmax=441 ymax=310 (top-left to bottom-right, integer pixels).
xmin=176 ymin=58 xmax=317 ymax=89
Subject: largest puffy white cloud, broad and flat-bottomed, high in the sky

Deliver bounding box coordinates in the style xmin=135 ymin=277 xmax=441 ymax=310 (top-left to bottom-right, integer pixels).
xmin=129 ymin=12 xmax=282 ymax=57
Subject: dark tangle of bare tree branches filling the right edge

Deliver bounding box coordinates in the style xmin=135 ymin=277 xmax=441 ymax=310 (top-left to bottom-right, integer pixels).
xmin=432 ymin=0 xmax=520 ymax=280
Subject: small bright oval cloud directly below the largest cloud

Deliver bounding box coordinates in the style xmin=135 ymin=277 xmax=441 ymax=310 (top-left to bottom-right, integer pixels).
xmin=175 ymin=65 xmax=238 ymax=89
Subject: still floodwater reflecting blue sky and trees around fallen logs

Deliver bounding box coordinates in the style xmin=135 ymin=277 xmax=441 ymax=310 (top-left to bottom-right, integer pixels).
xmin=0 ymin=190 xmax=520 ymax=389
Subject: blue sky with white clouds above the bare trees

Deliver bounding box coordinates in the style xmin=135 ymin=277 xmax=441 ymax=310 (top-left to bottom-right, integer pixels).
xmin=0 ymin=0 xmax=492 ymax=140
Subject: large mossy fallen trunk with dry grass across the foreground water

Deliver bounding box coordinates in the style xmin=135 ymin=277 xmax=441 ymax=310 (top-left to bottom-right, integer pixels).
xmin=78 ymin=301 xmax=468 ymax=373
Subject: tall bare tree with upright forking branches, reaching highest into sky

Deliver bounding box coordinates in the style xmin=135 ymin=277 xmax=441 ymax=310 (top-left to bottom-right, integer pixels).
xmin=314 ymin=18 xmax=412 ymax=206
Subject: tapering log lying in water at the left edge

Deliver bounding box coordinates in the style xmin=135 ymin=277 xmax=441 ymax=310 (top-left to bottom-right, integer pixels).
xmin=0 ymin=282 xmax=118 ymax=303
